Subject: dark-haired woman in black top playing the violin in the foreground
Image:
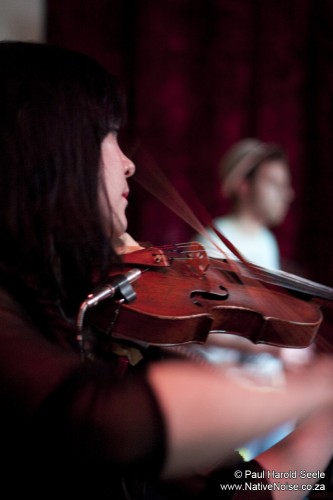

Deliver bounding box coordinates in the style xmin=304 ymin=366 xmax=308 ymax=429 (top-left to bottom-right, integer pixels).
xmin=0 ymin=42 xmax=333 ymax=500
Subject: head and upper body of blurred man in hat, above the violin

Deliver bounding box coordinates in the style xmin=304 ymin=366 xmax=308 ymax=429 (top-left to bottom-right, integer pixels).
xmin=195 ymin=139 xmax=294 ymax=269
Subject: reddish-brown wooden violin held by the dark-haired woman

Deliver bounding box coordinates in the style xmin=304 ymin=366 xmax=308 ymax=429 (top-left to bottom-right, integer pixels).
xmin=85 ymin=242 xmax=333 ymax=348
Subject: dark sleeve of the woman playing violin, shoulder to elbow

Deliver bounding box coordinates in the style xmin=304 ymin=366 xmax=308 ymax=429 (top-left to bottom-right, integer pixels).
xmin=0 ymin=294 xmax=165 ymax=474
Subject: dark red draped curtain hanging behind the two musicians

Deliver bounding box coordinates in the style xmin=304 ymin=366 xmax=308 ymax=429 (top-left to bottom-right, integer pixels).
xmin=47 ymin=0 xmax=333 ymax=286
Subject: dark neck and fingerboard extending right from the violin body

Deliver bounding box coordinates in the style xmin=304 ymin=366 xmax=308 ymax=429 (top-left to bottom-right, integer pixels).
xmin=240 ymin=263 xmax=333 ymax=307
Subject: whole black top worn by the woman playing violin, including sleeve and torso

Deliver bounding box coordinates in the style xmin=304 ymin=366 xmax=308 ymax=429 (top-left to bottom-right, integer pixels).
xmin=0 ymin=290 xmax=271 ymax=500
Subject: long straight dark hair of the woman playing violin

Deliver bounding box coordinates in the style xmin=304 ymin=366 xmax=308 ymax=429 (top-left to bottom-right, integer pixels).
xmin=0 ymin=42 xmax=123 ymax=322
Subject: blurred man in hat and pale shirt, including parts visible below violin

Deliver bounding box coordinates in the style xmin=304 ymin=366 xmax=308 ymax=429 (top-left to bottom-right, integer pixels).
xmin=194 ymin=138 xmax=311 ymax=459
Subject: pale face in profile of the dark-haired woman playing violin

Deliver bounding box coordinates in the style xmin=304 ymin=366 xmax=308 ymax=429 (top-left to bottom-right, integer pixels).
xmin=100 ymin=133 xmax=135 ymax=237
